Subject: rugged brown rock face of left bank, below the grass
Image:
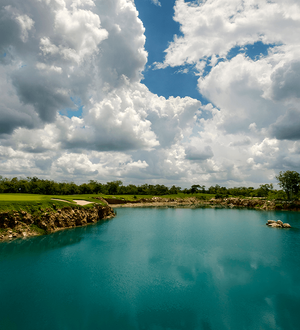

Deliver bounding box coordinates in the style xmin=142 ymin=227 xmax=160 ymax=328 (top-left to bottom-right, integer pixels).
xmin=0 ymin=204 xmax=115 ymax=241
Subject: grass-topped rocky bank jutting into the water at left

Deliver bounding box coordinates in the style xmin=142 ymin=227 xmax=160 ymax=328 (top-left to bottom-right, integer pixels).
xmin=0 ymin=194 xmax=115 ymax=241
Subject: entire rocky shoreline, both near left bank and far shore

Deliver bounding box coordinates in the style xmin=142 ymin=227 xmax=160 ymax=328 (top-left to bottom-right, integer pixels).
xmin=0 ymin=197 xmax=300 ymax=241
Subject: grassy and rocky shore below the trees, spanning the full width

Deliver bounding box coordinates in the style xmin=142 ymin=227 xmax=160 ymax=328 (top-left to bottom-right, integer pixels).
xmin=0 ymin=188 xmax=300 ymax=241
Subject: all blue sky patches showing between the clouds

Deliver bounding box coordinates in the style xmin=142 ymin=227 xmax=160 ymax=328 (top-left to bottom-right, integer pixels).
xmin=61 ymin=0 xmax=275 ymax=118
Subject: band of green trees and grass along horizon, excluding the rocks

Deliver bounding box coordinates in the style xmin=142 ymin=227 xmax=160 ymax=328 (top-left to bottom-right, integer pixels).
xmin=0 ymin=171 xmax=300 ymax=204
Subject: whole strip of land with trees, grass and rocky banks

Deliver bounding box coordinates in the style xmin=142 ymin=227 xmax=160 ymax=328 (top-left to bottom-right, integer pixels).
xmin=0 ymin=171 xmax=300 ymax=240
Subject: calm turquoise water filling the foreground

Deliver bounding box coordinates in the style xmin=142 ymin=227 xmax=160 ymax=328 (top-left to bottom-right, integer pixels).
xmin=0 ymin=208 xmax=300 ymax=330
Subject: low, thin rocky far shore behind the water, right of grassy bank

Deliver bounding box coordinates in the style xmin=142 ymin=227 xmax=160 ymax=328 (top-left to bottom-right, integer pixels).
xmin=105 ymin=197 xmax=300 ymax=211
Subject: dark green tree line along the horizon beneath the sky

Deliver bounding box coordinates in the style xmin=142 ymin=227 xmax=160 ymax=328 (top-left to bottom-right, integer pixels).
xmin=0 ymin=171 xmax=300 ymax=199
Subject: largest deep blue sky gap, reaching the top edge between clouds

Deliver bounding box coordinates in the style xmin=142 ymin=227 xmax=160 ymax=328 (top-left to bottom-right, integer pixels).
xmin=135 ymin=0 xmax=205 ymax=102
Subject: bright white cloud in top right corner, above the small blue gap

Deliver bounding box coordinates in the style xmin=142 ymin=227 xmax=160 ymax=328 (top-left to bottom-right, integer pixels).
xmin=164 ymin=0 xmax=300 ymax=66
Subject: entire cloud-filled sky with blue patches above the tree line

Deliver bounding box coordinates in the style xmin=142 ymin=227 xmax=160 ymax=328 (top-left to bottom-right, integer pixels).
xmin=0 ymin=0 xmax=300 ymax=188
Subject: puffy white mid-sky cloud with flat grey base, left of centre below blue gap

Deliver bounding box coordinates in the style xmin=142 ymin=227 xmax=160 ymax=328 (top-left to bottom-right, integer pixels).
xmin=60 ymin=88 xmax=159 ymax=151
